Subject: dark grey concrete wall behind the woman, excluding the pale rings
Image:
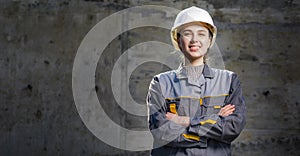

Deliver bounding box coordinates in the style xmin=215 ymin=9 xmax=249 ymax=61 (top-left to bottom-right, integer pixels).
xmin=0 ymin=0 xmax=300 ymax=156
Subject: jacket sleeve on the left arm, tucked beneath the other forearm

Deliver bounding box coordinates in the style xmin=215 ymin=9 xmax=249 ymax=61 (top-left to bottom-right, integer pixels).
xmin=147 ymin=77 xmax=206 ymax=148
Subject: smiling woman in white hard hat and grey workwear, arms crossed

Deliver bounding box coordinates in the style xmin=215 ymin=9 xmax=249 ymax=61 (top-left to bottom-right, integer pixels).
xmin=147 ymin=7 xmax=246 ymax=156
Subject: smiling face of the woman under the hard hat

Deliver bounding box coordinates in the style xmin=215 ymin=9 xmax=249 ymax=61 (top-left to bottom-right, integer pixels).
xmin=178 ymin=24 xmax=211 ymax=62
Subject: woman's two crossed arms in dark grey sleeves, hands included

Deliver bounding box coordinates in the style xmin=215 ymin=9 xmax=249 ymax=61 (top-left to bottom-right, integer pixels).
xmin=147 ymin=75 xmax=246 ymax=144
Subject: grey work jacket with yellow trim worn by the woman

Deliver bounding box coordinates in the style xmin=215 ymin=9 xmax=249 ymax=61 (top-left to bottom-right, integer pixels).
xmin=147 ymin=64 xmax=246 ymax=156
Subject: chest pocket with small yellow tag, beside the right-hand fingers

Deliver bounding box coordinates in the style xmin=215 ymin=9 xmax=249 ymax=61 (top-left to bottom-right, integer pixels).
xmin=203 ymin=95 xmax=227 ymax=115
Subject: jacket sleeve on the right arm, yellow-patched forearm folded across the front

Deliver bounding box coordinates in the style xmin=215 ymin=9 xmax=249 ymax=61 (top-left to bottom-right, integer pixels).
xmin=188 ymin=74 xmax=246 ymax=143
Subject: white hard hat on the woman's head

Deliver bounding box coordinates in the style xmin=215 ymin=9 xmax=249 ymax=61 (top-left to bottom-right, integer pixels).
xmin=171 ymin=6 xmax=217 ymax=50
